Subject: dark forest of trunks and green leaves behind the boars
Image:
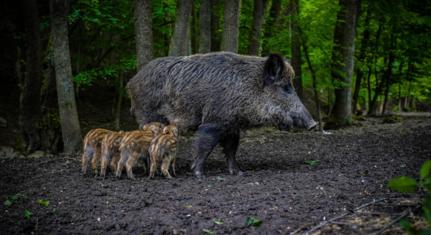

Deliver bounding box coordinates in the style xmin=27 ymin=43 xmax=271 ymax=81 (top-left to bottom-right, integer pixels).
xmin=0 ymin=0 xmax=431 ymax=153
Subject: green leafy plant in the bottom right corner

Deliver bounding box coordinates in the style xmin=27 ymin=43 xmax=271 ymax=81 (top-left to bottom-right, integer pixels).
xmin=388 ymin=160 xmax=431 ymax=235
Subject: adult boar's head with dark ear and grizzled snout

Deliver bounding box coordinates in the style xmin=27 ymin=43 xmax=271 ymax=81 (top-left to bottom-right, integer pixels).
xmin=260 ymin=54 xmax=317 ymax=129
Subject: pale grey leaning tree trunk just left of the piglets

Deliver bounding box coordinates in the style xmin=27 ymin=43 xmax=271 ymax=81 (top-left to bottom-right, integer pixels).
xmin=50 ymin=0 xmax=81 ymax=154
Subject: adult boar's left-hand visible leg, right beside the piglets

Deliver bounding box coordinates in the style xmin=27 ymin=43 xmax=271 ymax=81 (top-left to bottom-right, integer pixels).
xmin=191 ymin=124 xmax=222 ymax=178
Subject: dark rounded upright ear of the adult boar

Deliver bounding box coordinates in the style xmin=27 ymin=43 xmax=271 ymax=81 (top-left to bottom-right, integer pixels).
xmin=263 ymin=54 xmax=286 ymax=85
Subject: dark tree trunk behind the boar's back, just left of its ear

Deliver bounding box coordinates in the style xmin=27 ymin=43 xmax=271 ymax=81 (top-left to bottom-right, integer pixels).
xmin=248 ymin=0 xmax=267 ymax=56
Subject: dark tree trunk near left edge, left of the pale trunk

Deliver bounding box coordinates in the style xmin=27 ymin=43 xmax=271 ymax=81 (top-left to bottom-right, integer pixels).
xmin=19 ymin=0 xmax=42 ymax=154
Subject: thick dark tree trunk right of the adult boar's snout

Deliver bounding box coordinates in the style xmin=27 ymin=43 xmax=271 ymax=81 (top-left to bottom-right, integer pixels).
xmin=331 ymin=0 xmax=359 ymax=126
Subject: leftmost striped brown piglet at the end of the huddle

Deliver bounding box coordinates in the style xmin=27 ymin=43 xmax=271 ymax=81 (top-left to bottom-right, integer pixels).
xmin=82 ymin=128 xmax=112 ymax=175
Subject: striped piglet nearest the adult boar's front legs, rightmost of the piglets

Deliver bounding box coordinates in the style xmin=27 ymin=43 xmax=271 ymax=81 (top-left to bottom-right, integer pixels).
xmin=148 ymin=124 xmax=178 ymax=179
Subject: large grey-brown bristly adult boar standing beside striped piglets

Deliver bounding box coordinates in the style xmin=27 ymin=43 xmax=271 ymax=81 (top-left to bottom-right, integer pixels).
xmin=127 ymin=52 xmax=316 ymax=178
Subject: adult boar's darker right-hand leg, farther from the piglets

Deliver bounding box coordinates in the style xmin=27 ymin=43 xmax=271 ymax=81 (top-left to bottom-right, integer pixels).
xmin=220 ymin=130 xmax=243 ymax=175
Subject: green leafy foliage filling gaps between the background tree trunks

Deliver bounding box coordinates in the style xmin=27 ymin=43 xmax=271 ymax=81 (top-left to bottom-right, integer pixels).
xmin=62 ymin=0 xmax=431 ymax=116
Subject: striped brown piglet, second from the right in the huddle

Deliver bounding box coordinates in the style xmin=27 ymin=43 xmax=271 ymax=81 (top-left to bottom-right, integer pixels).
xmin=116 ymin=122 xmax=164 ymax=179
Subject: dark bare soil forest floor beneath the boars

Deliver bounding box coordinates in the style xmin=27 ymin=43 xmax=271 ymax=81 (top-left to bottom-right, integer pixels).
xmin=0 ymin=118 xmax=431 ymax=234
